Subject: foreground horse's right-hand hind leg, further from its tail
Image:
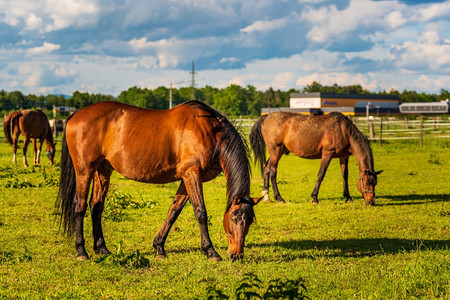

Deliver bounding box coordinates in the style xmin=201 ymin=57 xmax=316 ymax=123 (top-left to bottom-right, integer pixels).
xmin=89 ymin=169 xmax=112 ymax=255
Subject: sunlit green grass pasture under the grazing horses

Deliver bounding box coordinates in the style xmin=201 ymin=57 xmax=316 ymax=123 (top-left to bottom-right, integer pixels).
xmin=0 ymin=139 xmax=450 ymax=299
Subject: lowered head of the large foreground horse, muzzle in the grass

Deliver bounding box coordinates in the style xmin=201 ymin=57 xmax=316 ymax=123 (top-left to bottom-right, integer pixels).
xmin=223 ymin=196 xmax=263 ymax=261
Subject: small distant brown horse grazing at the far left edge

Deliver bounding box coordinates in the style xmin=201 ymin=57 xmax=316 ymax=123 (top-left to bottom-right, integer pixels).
xmin=3 ymin=109 xmax=56 ymax=167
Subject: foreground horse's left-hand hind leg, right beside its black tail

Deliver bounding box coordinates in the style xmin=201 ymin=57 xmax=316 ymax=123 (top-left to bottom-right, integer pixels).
xmin=75 ymin=176 xmax=91 ymax=260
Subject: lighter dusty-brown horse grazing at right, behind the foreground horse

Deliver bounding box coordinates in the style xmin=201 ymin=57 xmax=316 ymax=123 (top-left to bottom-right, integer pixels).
xmin=250 ymin=112 xmax=382 ymax=205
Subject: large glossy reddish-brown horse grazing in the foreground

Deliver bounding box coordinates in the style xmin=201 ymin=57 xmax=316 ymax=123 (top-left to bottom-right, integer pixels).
xmin=56 ymin=101 xmax=262 ymax=260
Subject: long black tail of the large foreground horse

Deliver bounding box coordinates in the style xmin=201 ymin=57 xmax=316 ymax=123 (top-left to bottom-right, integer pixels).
xmin=55 ymin=116 xmax=76 ymax=235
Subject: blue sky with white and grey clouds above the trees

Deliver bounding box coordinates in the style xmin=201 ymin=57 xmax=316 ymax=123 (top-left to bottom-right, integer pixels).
xmin=0 ymin=0 xmax=450 ymax=95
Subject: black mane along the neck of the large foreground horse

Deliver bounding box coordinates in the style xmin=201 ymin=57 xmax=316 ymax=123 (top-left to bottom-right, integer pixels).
xmin=180 ymin=100 xmax=254 ymax=213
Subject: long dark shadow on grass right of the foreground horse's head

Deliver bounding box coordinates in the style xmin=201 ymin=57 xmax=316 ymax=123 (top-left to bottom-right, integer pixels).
xmin=247 ymin=238 xmax=450 ymax=261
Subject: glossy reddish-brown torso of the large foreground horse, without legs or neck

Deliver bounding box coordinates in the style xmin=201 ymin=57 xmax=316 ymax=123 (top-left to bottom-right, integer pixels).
xmin=66 ymin=102 xmax=223 ymax=183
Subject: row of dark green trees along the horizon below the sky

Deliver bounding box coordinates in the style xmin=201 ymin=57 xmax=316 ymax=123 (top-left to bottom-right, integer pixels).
xmin=0 ymin=81 xmax=450 ymax=117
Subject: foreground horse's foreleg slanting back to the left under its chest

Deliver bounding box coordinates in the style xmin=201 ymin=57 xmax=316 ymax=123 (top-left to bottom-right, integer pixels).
xmin=153 ymin=181 xmax=189 ymax=258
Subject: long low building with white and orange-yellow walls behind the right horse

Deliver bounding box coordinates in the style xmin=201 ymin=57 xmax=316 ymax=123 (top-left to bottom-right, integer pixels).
xmin=262 ymin=93 xmax=400 ymax=115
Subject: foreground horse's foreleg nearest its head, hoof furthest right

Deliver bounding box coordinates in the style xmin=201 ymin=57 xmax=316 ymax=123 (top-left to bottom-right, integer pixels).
xmin=183 ymin=169 xmax=222 ymax=261
